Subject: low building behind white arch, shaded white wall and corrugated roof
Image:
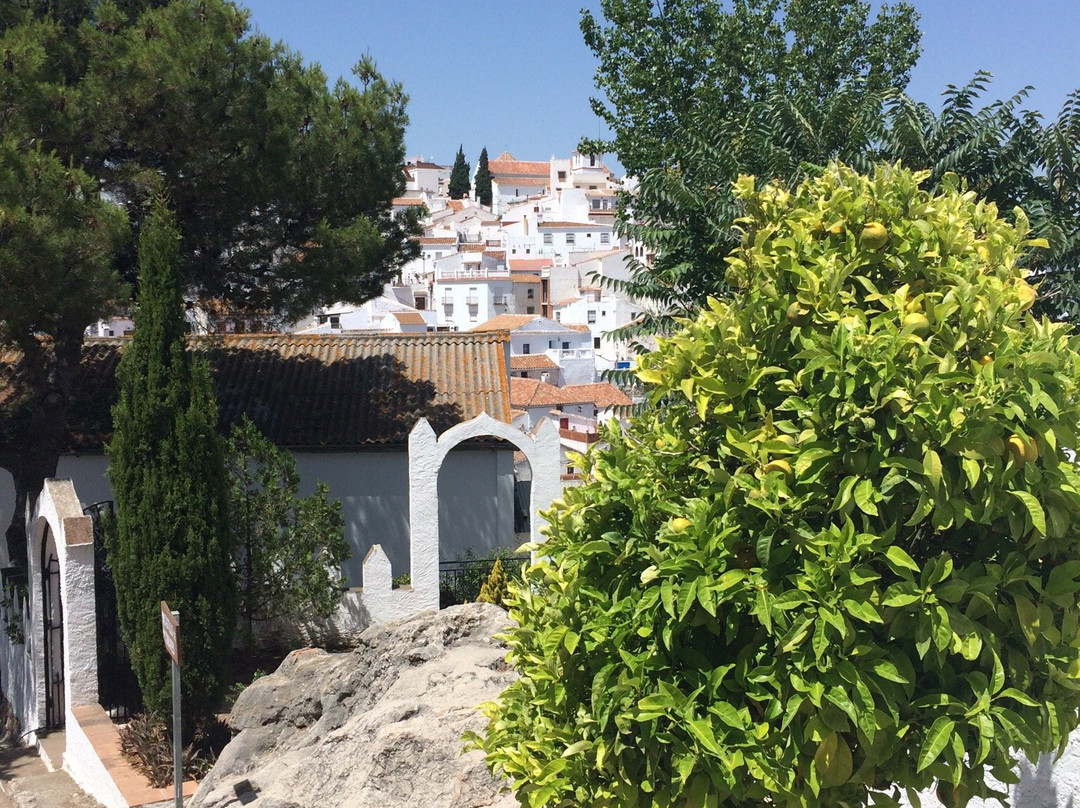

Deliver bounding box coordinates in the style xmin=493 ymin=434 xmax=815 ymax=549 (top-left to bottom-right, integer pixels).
xmin=0 ymin=333 xmax=516 ymax=587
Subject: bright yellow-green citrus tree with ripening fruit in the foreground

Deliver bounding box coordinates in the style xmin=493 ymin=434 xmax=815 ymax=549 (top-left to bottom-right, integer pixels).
xmin=477 ymin=165 xmax=1080 ymax=808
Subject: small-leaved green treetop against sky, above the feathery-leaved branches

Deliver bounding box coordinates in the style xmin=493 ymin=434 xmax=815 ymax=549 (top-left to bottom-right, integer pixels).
xmin=581 ymin=0 xmax=920 ymax=175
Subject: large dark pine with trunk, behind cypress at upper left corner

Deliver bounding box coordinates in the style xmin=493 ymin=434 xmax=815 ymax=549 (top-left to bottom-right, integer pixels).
xmin=0 ymin=0 xmax=419 ymax=564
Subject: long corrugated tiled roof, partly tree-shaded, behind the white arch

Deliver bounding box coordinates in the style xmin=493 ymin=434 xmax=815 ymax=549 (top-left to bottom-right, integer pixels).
xmin=0 ymin=334 xmax=510 ymax=454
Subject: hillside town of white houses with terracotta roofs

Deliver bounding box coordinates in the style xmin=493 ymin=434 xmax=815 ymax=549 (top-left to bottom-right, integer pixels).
xmin=87 ymin=152 xmax=647 ymax=483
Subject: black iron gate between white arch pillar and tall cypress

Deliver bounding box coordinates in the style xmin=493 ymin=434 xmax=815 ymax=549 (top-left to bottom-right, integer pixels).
xmin=83 ymin=500 xmax=143 ymax=721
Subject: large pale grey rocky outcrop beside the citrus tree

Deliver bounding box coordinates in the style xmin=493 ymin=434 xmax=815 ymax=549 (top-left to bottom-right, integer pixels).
xmin=189 ymin=604 xmax=517 ymax=808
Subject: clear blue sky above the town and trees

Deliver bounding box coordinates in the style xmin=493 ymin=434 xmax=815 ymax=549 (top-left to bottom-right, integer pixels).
xmin=240 ymin=0 xmax=1080 ymax=173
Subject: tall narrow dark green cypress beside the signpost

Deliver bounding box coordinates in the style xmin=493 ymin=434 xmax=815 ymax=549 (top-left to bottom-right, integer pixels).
xmin=108 ymin=202 xmax=237 ymax=727
